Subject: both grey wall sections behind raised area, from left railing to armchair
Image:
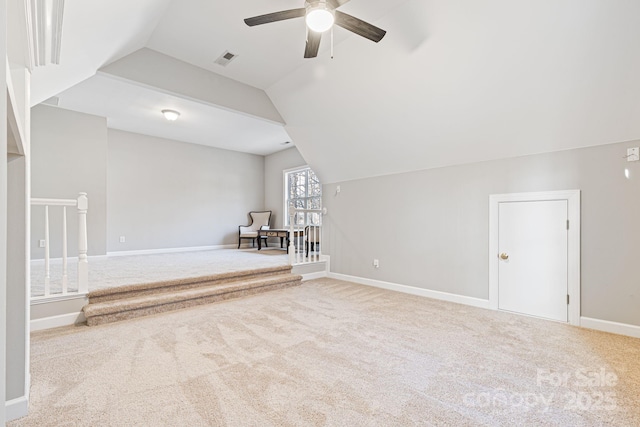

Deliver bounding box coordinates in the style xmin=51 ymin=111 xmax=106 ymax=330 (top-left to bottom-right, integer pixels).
xmin=31 ymin=105 xmax=264 ymax=258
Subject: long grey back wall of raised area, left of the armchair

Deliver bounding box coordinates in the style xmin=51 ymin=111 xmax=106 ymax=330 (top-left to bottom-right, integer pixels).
xmin=107 ymin=129 xmax=264 ymax=252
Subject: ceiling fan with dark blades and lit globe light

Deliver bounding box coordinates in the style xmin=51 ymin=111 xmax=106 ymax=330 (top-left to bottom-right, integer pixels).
xmin=244 ymin=0 xmax=387 ymax=58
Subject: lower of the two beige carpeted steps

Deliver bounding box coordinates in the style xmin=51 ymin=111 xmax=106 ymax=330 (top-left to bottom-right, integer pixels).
xmin=83 ymin=273 xmax=302 ymax=326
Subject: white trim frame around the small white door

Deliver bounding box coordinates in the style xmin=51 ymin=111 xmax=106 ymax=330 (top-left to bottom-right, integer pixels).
xmin=489 ymin=190 xmax=580 ymax=326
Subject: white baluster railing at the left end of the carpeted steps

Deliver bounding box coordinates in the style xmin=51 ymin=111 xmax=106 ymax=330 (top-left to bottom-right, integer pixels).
xmin=31 ymin=193 xmax=89 ymax=299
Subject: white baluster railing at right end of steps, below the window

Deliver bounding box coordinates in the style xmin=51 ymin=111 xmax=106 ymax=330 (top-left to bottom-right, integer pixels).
xmin=289 ymin=206 xmax=327 ymax=265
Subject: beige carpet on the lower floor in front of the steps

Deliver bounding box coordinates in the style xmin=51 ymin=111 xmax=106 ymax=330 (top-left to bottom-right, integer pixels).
xmin=9 ymin=279 xmax=640 ymax=427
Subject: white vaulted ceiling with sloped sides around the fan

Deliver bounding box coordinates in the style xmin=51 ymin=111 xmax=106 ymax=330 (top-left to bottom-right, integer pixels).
xmin=27 ymin=0 xmax=640 ymax=182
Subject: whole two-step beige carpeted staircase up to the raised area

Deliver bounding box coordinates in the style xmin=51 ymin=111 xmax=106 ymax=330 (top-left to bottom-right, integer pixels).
xmin=82 ymin=265 xmax=302 ymax=326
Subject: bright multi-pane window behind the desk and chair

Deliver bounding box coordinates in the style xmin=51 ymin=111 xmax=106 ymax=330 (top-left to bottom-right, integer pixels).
xmin=284 ymin=167 xmax=322 ymax=225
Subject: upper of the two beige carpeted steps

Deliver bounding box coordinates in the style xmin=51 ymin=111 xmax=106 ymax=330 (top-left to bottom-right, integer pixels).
xmin=87 ymin=265 xmax=291 ymax=304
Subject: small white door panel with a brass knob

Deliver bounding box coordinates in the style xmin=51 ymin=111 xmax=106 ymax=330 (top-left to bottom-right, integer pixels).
xmin=498 ymin=200 xmax=568 ymax=322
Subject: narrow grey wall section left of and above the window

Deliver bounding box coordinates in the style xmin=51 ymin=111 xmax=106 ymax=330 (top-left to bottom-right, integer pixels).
xmin=264 ymin=147 xmax=306 ymax=228
